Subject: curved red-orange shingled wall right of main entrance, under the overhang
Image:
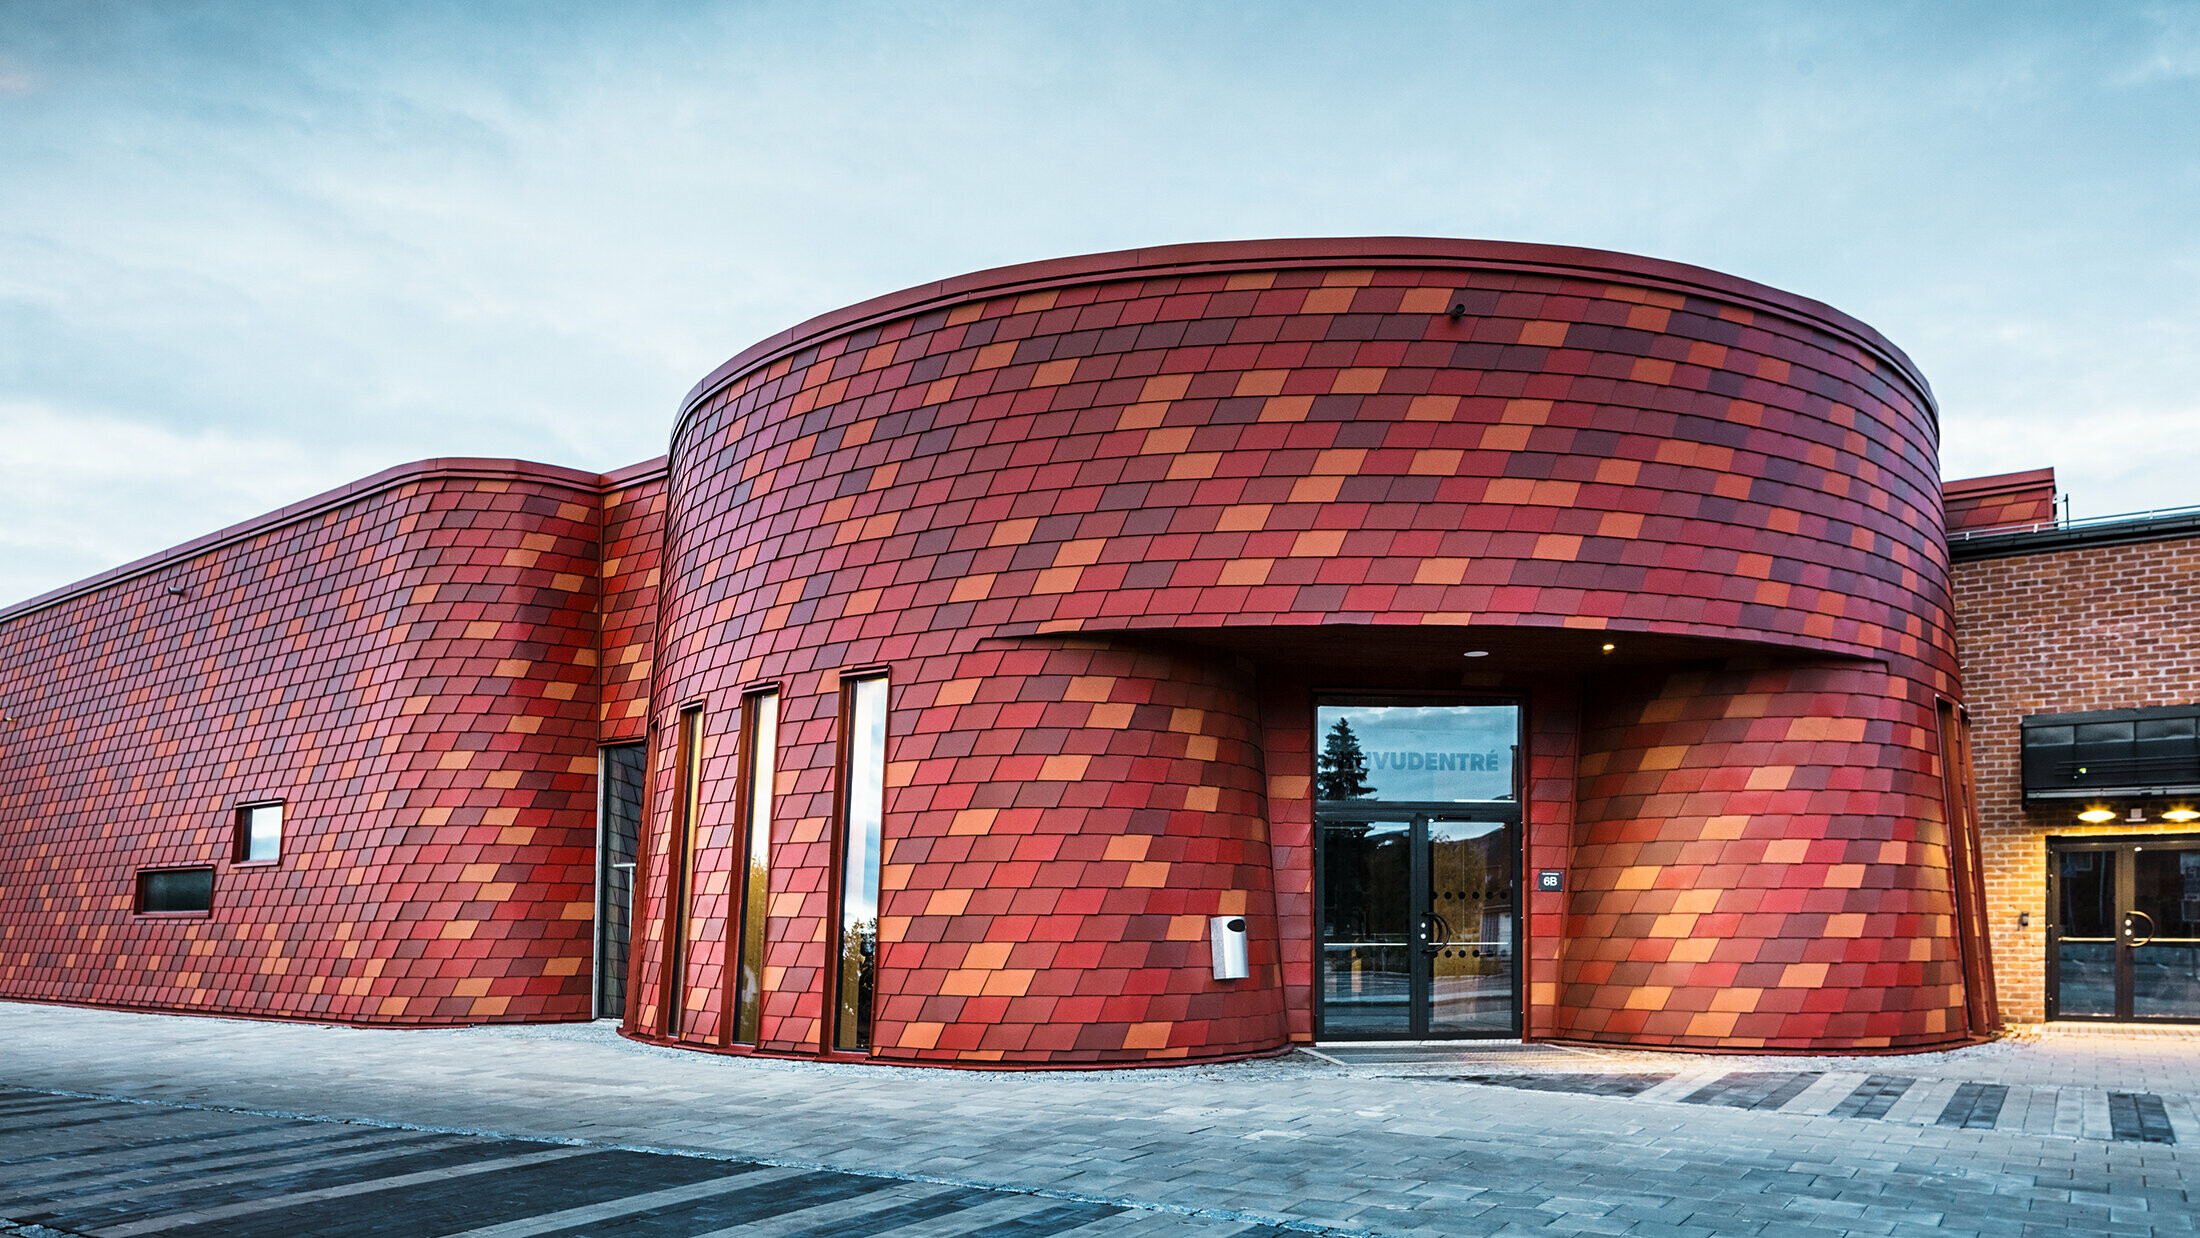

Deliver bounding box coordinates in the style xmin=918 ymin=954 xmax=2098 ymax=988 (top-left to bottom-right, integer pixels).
xmin=1555 ymin=664 xmax=1967 ymax=1049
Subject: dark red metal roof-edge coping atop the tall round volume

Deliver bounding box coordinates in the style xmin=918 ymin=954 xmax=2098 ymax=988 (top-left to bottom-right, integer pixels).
xmin=671 ymin=237 xmax=1940 ymax=449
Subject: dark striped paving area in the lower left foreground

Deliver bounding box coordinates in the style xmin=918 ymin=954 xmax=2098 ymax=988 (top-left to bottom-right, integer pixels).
xmin=0 ymin=1091 xmax=1302 ymax=1238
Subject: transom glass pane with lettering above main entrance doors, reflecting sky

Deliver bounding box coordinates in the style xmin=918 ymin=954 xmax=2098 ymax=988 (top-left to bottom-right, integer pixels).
xmin=1313 ymin=706 xmax=1520 ymax=800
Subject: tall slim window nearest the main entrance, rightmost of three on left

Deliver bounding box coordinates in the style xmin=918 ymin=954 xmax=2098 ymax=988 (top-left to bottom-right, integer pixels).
xmin=834 ymin=675 xmax=887 ymax=1049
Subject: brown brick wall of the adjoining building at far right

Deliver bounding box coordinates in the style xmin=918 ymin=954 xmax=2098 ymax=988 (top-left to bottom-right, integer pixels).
xmin=1954 ymin=537 xmax=2200 ymax=1023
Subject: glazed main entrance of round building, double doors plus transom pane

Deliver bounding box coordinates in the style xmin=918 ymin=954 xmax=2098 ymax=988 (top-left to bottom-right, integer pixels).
xmin=1313 ymin=697 xmax=1520 ymax=1040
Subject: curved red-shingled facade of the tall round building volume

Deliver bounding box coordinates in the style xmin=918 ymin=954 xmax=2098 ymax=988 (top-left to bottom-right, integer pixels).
xmin=629 ymin=240 xmax=1993 ymax=1064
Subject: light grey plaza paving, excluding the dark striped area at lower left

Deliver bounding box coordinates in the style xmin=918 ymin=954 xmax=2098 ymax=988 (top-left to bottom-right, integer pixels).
xmin=0 ymin=1005 xmax=2200 ymax=1238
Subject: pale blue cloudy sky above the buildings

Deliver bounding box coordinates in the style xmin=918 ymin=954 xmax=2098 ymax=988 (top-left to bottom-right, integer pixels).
xmin=0 ymin=0 xmax=2200 ymax=605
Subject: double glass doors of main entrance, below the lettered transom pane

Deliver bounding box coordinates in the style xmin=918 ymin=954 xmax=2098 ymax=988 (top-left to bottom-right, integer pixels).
xmin=1320 ymin=809 xmax=1518 ymax=1040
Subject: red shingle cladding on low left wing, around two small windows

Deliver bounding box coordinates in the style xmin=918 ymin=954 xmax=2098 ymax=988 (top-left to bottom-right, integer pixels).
xmin=0 ymin=462 xmax=596 ymax=1023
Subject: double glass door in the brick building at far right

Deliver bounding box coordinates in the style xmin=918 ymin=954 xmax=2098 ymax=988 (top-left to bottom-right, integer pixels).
xmin=2048 ymin=838 xmax=2200 ymax=1020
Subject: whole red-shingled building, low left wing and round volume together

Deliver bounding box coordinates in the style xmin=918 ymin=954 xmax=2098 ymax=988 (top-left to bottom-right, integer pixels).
xmin=0 ymin=240 xmax=2182 ymax=1066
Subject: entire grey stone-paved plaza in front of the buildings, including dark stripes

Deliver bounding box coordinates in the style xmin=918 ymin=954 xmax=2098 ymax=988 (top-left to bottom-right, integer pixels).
xmin=0 ymin=1003 xmax=2200 ymax=1238
